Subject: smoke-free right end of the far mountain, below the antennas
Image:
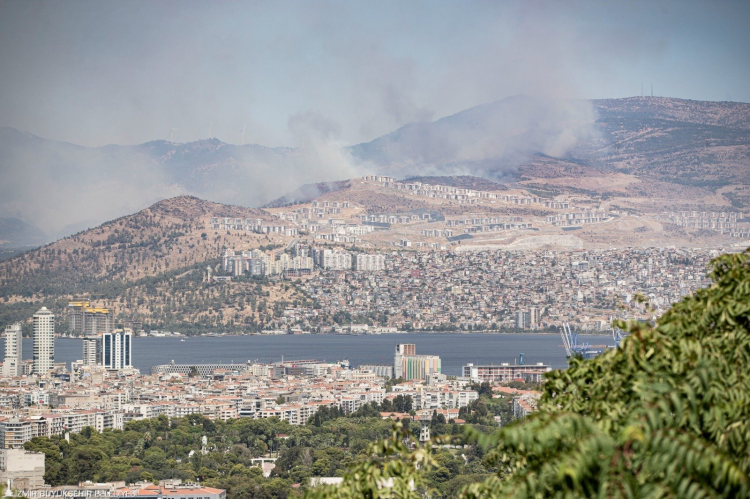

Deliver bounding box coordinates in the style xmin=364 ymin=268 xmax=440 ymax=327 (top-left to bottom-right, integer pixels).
xmin=592 ymin=97 xmax=750 ymax=186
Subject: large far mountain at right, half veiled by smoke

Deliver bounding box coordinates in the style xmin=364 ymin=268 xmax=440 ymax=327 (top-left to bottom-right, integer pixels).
xmin=352 ymin=97 xmax=750 ymax=199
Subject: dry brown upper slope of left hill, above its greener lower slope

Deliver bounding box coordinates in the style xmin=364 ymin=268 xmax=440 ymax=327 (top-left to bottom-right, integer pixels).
xmin=0 ymin=196 xmax=288 ymax=296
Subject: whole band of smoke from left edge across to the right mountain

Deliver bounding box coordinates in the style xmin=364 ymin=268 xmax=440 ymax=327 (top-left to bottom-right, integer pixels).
xmin=0 ymin=98 xmax=595 ymax=242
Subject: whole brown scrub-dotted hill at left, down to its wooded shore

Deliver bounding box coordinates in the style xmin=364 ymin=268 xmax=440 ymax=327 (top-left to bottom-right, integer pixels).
xmin=0 ymin=196 xmax=312 ymax=332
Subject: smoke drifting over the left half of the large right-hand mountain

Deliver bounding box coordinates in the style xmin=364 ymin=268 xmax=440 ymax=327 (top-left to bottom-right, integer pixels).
xmin=354 ymin=97 xmax=597 ymax=180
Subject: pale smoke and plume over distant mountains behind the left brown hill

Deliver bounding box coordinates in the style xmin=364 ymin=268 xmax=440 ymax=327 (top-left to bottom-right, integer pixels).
xmin=0 ymin=119 xmax=364 ymax=238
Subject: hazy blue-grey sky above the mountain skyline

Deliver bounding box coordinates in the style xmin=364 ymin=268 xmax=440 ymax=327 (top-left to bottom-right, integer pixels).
xmin=0 ymin=0 xmax=750 ymax=146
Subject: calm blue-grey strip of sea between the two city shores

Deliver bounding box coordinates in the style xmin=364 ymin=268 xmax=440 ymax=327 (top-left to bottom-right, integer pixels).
xmin=0 ymin=333 xmax=613 ymax=375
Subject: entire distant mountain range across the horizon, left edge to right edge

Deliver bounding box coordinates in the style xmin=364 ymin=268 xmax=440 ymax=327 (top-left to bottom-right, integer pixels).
xmin=0 ymin=96 xmax=750 ymax=242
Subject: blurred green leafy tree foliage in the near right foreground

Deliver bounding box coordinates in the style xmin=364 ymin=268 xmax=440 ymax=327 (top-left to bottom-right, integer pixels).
xmin=312 ymin=250 xmax=750 ymax=498
